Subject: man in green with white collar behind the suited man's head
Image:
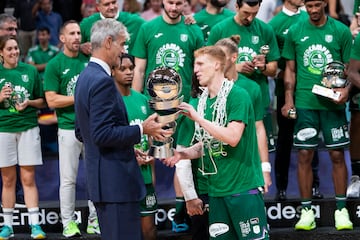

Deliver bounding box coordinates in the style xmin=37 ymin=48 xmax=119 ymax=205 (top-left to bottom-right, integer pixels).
xmin=80 ymin=0 xmax=145 ymax=55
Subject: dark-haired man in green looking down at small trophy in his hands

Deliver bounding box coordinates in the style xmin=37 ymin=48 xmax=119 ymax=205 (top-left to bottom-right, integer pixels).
xmin=208 ymin=0 xmax=280 ymax=156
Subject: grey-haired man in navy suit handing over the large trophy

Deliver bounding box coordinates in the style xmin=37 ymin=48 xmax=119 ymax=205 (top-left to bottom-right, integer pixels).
xmin=75 ymin=19 xmax=171 ymax=240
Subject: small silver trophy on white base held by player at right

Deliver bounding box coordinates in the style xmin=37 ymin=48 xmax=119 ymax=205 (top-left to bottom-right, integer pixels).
xmin=312 ymin=61 xmax=347 ymax=100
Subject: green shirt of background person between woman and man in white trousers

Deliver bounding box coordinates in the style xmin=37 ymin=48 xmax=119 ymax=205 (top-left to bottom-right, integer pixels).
xmin=26 ymin=45 xmax=59 ymax=78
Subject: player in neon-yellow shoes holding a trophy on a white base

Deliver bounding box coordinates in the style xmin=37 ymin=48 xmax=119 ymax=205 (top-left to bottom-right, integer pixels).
xmin=281 ymin=0 xmax=353 ymax=230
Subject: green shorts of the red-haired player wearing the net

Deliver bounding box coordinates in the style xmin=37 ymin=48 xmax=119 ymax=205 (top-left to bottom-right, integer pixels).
xmin=209 ymin=189 xmax=269 ymax=240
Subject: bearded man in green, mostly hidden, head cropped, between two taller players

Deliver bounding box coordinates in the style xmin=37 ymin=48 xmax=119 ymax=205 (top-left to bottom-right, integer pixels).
xmin=194 ymin=0 xmax=234 ymax=42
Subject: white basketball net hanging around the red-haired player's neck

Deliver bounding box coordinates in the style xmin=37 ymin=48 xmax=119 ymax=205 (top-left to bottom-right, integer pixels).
xmin=191 ymin=78 xmax=234 ymax=175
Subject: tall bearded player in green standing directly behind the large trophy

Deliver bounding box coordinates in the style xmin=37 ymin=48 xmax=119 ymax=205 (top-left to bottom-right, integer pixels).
xmin=132 ymin=0 xmax=204 ymax=101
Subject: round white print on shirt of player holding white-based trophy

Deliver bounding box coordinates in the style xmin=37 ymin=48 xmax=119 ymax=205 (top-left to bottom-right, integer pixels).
xmin=303 ymin=44 xmax=333 ymax=75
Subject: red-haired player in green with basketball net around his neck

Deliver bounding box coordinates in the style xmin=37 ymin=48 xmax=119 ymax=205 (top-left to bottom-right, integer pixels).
xmin=164 ymin=46 xmax=269 ymax=239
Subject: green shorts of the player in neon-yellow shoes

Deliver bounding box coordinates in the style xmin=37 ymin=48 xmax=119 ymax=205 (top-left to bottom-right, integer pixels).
xmin=294 ymin=109 xmax=350 ymax=149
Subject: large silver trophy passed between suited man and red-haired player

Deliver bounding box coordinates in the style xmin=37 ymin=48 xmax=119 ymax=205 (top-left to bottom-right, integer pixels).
xmin=147 ymin=67 xmax=183 ymax=159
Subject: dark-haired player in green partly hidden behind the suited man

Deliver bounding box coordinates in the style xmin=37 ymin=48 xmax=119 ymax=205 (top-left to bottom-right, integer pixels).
xmin=111 ymin=54 xmax=157 ymax=240
